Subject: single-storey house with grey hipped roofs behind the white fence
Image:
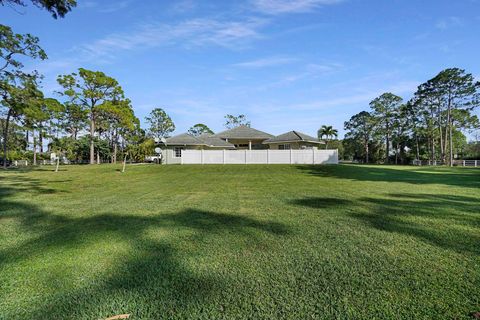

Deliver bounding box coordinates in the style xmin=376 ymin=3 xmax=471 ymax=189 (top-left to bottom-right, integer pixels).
xmin=163 ymin=125 xmax=324 ymax=164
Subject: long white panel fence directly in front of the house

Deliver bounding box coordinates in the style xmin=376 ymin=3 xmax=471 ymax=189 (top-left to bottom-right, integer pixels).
xmin=181 ymin=149 xmax=338 ymax=164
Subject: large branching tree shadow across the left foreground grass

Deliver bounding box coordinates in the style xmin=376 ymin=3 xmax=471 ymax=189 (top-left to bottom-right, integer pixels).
xmin=0 ymin=178 xmax=289 ymax=319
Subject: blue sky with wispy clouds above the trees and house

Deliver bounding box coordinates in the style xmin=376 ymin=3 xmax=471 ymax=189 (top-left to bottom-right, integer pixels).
xmin=0 ymin=0 xmax=480 ymax=135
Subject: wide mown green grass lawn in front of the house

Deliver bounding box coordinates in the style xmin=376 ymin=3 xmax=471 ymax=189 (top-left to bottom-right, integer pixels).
xmin=0 ymin=165 xmax=480 ymax=319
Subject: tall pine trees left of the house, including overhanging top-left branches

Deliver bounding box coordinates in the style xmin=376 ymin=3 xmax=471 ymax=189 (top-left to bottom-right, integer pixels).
xmin=0 ymin=0 xmax=169 ymax=167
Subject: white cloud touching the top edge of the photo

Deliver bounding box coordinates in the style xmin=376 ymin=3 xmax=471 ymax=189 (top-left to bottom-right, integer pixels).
xmin=252 ymin=0 xmax=343 ymax=14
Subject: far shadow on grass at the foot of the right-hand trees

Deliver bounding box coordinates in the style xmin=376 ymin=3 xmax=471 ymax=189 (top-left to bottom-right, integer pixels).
xmin=297 ymin=164 xmax=480 ymax=188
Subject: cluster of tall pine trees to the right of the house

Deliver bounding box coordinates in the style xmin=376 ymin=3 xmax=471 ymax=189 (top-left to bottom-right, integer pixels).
xmin=343 ymin=68 xmax=480 ymax=165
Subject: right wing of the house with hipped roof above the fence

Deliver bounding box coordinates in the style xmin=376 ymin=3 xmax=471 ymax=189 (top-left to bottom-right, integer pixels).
xmin=263 ymin=131 xmax=325 ymax=150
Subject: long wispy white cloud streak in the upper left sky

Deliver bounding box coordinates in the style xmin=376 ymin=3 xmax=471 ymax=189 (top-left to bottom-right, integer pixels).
xmin=81 ymin=19 xmax=266 ymax=58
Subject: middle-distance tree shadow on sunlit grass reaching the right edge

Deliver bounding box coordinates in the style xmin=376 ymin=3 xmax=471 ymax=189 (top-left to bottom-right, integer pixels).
xmin=291 ymin=194 xmax=480 ymax=255
